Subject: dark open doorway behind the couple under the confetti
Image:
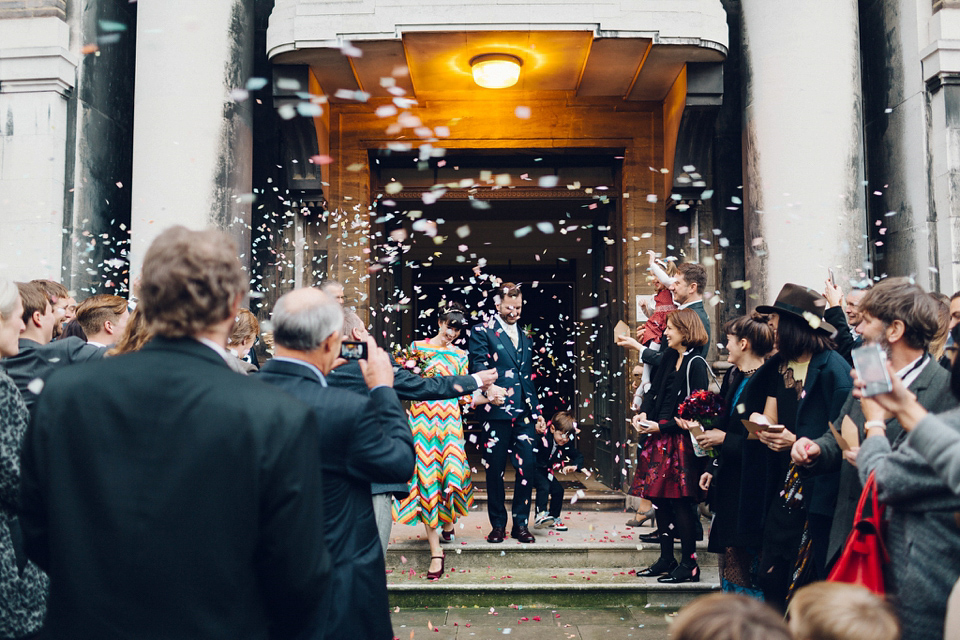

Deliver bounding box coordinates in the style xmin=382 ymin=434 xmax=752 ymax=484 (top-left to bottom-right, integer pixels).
xmin=371 ymin=150 xmax=629 ymax=488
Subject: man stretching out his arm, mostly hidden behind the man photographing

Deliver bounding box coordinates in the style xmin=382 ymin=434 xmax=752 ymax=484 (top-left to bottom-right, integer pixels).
xmin=327 ymin=309 xmax=503 ymax=557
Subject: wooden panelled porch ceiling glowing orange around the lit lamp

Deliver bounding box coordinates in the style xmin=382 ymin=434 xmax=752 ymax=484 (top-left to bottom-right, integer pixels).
xmin=273 ymin=31 xmax=724 ymax=101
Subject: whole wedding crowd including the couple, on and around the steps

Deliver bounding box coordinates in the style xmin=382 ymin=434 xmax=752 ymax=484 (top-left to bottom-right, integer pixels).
xmin=0 ymin=227 xmax=960 ymax=640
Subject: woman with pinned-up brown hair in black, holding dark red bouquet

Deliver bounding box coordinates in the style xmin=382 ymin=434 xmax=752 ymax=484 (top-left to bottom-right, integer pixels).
xmin=696 ymin=313 xmax=773 ymax=600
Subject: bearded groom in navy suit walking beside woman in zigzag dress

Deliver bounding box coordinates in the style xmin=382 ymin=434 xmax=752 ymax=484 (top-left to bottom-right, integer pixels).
xmin=469 ymin=282 xmax=543 ymax=543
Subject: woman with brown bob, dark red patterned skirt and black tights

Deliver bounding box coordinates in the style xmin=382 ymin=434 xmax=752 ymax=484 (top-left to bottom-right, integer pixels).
xmin=633 ymin=309 xmax=709 ymax=583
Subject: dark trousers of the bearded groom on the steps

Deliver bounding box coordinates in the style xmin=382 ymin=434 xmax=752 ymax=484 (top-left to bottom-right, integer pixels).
xmin=483 ymin=415 xmax=536 ymax=528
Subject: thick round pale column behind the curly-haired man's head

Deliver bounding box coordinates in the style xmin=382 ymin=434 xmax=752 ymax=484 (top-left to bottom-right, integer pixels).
xmin=131 ymin=0 xmax=253 ymax=275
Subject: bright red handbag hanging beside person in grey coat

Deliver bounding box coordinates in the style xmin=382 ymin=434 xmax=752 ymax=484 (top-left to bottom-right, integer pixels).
xmin=827 ymin=472 xmax=890 ymax=595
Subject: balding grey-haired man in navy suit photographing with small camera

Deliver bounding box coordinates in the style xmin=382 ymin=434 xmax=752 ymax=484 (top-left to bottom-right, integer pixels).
xmin=257 ymin=289 xmax=415 ymax=640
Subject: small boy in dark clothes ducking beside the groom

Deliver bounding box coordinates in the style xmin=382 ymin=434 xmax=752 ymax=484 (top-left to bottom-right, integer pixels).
xmin=533 ymin=411 xmax=583 ymax=531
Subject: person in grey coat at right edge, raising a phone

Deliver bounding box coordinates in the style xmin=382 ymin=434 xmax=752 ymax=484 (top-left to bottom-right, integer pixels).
xmin=856 ymin=356 xmax=960 ymax=640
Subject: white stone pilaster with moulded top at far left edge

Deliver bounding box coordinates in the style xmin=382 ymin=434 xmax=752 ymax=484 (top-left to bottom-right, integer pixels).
xmin=0 ymin=14 xmax=79 ymax=281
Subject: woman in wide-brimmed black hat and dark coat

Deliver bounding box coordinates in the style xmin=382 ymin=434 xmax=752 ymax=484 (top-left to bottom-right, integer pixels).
xmin=741 ymin=284 xmax=853 ymax=608
